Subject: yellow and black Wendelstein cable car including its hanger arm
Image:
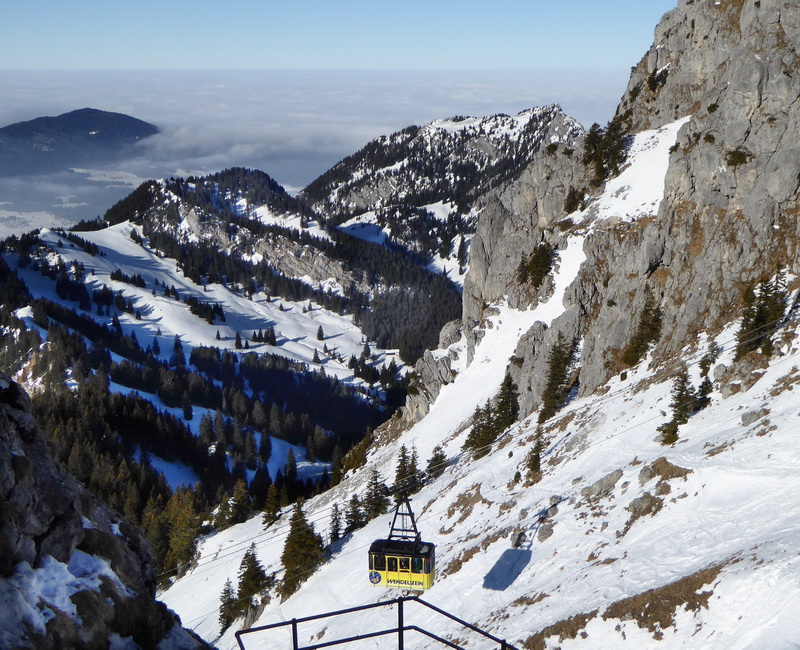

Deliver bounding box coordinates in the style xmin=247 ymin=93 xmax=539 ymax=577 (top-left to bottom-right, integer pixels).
xmin=369 ymin=496 xmax=436 ymax=589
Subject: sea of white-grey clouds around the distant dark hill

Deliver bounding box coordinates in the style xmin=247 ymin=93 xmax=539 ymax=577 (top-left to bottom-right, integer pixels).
xmin=0 ymin=70 xmax=629 ymax=237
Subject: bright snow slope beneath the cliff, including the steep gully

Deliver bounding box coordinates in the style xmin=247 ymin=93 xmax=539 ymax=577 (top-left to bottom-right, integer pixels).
xmin=162 ymin=114 xmax=800 ymax=650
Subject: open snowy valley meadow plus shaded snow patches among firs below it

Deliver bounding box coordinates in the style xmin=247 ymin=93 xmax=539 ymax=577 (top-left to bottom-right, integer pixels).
xmin=7 ymin=221 xmax=402 ymax=478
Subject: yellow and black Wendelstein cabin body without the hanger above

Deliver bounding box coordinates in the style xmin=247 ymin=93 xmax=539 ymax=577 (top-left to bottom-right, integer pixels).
xmin=369 ymin=539 xmax=436 ymax=589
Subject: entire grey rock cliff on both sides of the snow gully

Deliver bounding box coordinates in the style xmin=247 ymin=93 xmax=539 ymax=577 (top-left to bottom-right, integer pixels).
xmin=416 ymin=0 xmax=800 ymax=417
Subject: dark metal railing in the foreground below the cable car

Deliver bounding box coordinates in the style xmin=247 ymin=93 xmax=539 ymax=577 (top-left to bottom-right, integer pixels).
xmin=236 ymin=596 xmax=518 ymax=650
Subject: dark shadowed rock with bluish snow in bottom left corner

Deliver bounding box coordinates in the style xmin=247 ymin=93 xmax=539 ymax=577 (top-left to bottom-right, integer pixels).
xmin=0 ymin=377 xmax=207 ymax=648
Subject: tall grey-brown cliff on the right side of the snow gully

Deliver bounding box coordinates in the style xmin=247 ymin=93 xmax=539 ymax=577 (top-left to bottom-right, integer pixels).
xmin=581 ymin=0 xmax=800 ymax=391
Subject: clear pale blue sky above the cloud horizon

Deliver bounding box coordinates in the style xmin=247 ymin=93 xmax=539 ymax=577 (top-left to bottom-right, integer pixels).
xmin=0 ymin=0 xmax=677 ymax=70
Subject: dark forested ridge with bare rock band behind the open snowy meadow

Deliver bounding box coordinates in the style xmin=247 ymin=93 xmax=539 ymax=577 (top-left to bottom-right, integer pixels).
xmin=100 ymin=169 xmax=460 ymax=362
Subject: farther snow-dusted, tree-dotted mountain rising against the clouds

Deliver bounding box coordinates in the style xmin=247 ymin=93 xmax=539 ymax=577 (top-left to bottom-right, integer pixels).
xmin=299 ymin=106 xmax=583 ymax=284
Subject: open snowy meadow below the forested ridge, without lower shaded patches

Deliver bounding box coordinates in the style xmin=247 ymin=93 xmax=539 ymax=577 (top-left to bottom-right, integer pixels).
xmin=20 ymin=221 xmax=386 ymax=383
